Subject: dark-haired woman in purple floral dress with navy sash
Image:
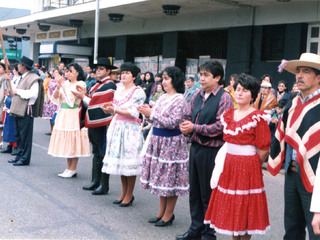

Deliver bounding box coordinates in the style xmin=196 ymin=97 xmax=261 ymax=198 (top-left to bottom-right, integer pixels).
xmin=138 ymin=67 xmax=189 ymax=227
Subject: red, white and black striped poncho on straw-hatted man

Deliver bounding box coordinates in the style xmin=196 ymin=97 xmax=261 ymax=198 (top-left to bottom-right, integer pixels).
xmin=268 ymin=94 xmax=320 ymax=192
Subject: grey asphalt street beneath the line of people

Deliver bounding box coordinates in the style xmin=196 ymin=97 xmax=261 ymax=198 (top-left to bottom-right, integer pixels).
xmin=0 ymin=119 xmax=284 ymax=240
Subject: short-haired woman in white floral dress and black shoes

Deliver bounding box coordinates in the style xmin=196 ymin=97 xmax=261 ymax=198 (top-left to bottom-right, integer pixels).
xmin=102 ymin=62 xmax=146 ymax=207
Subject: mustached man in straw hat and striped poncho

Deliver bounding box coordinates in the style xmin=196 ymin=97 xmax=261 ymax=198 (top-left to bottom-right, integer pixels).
xmin=268 ymin=53 xmax=320 ymax=240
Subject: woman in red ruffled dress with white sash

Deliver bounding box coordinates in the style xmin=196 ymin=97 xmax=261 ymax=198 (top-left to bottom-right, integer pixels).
xmin=204 ymin=73 xmax=271 ymax=240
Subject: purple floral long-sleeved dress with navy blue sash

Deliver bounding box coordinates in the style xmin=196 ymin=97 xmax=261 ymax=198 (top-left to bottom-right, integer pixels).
xmin=140 ymin=94 xmax=189 ymax=197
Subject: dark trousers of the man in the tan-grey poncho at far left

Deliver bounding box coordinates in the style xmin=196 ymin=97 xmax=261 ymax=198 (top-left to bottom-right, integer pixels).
xmin=14 ymin=115 xmax=33 ymax=165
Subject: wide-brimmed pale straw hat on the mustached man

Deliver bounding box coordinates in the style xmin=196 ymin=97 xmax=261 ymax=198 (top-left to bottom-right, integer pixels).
xmin=284 ymin=53 xmax=320 ymax=74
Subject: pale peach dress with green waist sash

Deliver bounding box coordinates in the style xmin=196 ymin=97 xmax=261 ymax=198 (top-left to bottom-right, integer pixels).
xmin=48 ymin=81 xmax=90 ymax=158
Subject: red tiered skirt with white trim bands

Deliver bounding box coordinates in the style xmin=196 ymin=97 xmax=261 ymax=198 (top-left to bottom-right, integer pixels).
xmin=204 ymin=153 xmax=270 ymax=236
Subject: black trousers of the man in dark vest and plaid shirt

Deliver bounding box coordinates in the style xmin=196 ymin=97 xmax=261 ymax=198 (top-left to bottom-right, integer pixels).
xmin=188 ymin=143 xmax=219 ymax=236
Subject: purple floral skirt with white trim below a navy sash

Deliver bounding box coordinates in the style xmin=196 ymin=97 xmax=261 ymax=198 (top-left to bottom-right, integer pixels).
xmin=140 ymin=135 xmax=189 ymax=197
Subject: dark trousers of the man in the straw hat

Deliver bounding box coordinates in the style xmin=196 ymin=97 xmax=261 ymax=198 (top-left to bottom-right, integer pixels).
xmin=283 ymin=170 xmax=320 ymax=240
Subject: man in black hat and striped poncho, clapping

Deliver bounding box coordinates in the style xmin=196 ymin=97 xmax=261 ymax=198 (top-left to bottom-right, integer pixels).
xmin=73 ymin=58 xmax=117 ymax=195
